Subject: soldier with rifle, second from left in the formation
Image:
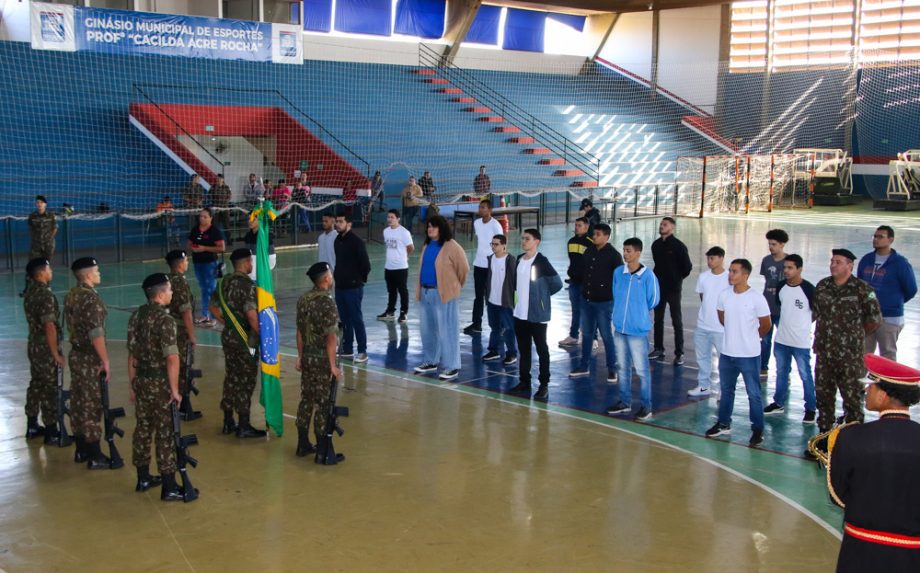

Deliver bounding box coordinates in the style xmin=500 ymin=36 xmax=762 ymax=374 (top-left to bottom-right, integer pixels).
xmin=64 ymin=257 xmax=110 ymax=470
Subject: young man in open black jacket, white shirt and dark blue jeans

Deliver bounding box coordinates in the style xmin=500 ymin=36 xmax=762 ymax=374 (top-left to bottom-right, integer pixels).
xmin=482 ymin=233 xmax=517 ymax=366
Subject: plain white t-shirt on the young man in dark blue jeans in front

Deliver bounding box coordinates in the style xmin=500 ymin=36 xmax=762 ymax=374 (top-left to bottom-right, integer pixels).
xmin=716 ymin=288 xmax=770 ymax=358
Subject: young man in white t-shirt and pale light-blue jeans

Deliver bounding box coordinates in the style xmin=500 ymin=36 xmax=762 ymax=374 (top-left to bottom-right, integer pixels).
xmin=687 ymin=247 xmax=731 ymax=398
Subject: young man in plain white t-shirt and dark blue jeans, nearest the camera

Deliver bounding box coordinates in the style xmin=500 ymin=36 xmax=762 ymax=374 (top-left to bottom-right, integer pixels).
xmin=706 ymin=259 xmax=771 ymax=447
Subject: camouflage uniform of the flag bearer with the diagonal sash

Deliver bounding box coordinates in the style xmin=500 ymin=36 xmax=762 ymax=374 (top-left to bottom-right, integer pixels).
xmin=210 ymin=271 xmax=259 ymax=416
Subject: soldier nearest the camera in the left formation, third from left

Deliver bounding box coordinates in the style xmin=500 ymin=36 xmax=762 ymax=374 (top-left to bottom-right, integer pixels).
xmin=128 ymin=273 xmax=182 ymax=501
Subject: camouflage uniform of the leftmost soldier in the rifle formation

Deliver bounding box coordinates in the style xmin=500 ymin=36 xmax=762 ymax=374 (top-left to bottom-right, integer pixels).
xmin=23 ymin=281 xmax=61 ymax=426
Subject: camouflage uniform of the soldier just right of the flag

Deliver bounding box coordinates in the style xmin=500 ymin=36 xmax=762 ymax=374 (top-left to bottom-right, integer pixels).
xmin=296 ymin=288 xmax=339 ymax=441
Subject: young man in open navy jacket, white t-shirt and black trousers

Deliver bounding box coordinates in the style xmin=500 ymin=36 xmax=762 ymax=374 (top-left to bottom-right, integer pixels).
xmin=510 ymin=229 xmax=564 ymax=401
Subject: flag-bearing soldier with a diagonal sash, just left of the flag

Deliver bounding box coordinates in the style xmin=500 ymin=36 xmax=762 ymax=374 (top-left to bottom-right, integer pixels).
xmin=209 ymin=249 xmax=265 ymax=438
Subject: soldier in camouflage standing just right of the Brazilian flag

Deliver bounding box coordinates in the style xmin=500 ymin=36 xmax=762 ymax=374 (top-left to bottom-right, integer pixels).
xmin=296 ymin=263 xmax=342 ymax=457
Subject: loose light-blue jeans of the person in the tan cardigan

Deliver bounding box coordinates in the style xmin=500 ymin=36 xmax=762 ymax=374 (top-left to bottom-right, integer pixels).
xmin=419 ymin=288 xmax=460 ymax=371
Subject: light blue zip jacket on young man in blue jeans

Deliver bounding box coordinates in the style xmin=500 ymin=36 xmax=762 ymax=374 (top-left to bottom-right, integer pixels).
xmin=613 ymin=265 xmax=661 ymax=336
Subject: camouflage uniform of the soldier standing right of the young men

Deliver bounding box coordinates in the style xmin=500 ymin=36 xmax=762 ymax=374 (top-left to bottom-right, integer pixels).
xmin=812 ymin=276 xmax=882 ymax=432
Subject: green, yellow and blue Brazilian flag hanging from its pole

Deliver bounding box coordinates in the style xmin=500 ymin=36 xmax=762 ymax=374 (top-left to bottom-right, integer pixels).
xmin=249 ymin=201 xmax=284 ymax=436
